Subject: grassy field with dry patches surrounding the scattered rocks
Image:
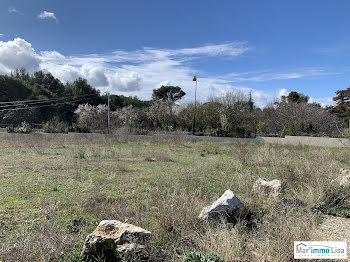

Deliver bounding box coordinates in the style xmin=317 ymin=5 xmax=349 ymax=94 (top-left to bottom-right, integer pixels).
xmin=0 ymin=135 xmax=350 ymax=262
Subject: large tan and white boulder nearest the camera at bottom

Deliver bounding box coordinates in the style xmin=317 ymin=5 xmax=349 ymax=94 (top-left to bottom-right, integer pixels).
xmin=82 ymin=220 xmax=151 ymax=262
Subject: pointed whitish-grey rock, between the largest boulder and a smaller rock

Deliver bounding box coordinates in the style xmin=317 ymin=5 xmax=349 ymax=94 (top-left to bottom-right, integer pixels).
xmin=199 ymin=190 xmax=243 ymax=222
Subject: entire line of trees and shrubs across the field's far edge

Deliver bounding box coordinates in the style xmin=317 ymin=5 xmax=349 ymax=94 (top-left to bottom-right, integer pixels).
xmin=0 ymin=69 xmax=350 ymax=137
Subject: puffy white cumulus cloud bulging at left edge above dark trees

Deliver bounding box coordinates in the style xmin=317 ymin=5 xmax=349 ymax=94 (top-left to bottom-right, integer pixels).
xmin=0 ymin=38 xmax=41 ymax=73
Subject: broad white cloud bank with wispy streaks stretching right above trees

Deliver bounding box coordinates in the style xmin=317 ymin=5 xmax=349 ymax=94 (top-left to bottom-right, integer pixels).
xmin=0 ymin=38 xmax=334 ymax=107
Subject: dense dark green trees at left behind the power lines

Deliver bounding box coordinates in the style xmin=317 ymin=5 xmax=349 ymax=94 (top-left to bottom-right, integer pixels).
xmin=0 ymin=69 xmax=150 ymax=126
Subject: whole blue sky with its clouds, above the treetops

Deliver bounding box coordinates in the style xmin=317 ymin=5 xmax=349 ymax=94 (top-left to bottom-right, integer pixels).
xmin=0 ymin=0 xmax=350 ymax=106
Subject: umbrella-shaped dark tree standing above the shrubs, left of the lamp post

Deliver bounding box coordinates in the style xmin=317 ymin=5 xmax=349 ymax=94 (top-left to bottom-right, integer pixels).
xmin=152 ymin=86 xmax=186 ymax=113
